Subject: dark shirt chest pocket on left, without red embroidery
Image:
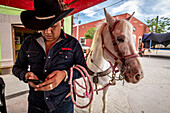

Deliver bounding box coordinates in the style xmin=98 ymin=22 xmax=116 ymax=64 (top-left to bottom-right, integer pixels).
xmin=26 ymin=51 xmax=39 ymax=64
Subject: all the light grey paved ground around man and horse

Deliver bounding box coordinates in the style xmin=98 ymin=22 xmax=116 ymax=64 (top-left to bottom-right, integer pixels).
xmin=0 ymin=52 xmax=170 ymax=113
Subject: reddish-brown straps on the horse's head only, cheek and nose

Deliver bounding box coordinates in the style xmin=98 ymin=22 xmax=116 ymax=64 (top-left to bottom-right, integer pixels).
xmin=101 ymin=20 xmax=138 ymax=73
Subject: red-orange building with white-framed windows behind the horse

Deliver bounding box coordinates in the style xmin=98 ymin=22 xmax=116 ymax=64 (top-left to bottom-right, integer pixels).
xmin=73 ymin=13 xmax=149 ymax=49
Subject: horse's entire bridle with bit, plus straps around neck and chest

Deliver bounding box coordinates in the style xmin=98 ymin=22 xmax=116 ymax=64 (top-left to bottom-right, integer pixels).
xmin=86 ymin=20 xmax=138 ymax=90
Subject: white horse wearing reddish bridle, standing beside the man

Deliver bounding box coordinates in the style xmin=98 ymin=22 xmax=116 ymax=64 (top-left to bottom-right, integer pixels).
xmin=87 ymin=9 xmax=143 ymax=113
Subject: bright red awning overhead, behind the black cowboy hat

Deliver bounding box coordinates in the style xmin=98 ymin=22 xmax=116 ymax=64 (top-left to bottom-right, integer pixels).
xmin=0 ymin=0 xmax=106 ymax=15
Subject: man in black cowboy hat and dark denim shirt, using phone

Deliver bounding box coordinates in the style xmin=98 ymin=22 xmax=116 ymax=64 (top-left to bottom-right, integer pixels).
xmin=13 ymin=0 xmax=86 ymax=113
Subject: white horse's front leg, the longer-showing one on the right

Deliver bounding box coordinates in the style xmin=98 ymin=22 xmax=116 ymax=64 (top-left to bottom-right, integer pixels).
xmin=102 ymin=87 xmax=109 ymax=113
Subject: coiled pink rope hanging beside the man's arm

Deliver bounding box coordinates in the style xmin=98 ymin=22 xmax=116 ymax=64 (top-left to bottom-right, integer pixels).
xmin=69 ymin=65 xmax=94 ymax=108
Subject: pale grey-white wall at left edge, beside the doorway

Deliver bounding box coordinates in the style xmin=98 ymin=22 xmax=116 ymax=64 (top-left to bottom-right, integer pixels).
xmin=0 ymin=14 xmax=21 ymax=73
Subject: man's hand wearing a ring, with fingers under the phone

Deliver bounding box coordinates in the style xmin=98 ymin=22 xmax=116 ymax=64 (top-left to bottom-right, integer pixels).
xmin=35 ymin=71 xmax=66 ymax=91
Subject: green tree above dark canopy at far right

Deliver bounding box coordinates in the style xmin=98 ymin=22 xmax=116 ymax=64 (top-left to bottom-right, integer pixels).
xmin=146 ymin=16 xmax=170 ymax=33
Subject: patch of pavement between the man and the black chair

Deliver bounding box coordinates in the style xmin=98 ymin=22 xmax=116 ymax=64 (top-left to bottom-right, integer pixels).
xmin=0 ymin=74 xmax=28 ymax=113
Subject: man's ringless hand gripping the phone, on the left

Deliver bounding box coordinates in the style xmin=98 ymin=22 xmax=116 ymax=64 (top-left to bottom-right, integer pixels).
xmin=25 ymin=72 xmax=39 ymax=88
